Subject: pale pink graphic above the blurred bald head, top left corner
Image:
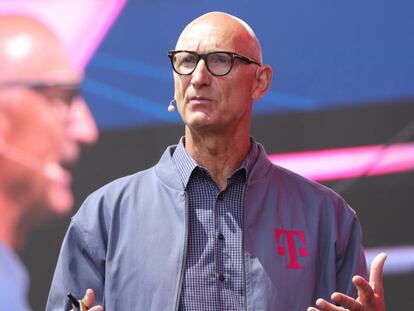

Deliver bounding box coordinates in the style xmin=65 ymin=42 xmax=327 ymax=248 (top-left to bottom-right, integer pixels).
xmin=0 ymin=0 xmax=126 ymax=68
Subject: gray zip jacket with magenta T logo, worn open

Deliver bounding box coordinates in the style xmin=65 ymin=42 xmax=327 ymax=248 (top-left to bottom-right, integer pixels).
xmin=46 ymin=145 xmax=366 ymax=311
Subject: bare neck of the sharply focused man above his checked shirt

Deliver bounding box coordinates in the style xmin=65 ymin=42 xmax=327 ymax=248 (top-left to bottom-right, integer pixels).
xmin=185 ymin=128 xmax=250 ymax=190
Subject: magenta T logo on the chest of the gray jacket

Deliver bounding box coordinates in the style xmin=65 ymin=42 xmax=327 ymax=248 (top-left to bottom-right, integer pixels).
xmin=275 ymin=228 xmax=308 ymax=269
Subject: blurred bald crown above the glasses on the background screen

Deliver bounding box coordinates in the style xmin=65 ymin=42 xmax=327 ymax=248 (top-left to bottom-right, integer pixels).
xmin=0 ymin=15 xmax=79 ymax=82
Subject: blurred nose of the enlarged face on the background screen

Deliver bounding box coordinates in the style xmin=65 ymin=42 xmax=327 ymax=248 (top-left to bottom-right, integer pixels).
xmin=67 ymin=98 xmax=99 ymax=145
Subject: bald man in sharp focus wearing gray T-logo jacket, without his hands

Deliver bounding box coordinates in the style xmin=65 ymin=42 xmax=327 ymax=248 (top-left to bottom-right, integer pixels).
xmin=46 ymin=12 xmax=366 ymax=311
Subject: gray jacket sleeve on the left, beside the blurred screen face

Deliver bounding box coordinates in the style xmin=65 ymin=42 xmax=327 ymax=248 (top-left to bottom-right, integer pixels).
xmin=46 ymin=198 xmax=106 ymax=311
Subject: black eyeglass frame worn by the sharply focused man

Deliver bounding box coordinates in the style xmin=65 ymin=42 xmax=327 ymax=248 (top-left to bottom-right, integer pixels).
xmin=168 ymin=50 xmax=262 ymax=77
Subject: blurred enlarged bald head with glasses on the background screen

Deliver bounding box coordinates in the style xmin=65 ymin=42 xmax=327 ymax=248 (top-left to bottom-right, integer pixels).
xmin=0 ymin=25 xmax=98 ymax=214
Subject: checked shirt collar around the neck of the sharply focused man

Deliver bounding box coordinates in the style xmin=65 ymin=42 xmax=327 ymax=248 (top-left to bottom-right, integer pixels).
xmin=172 ymin=136 xmax=259 ymax=188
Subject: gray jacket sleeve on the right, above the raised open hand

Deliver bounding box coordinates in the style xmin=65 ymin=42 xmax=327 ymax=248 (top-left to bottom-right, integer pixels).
xmin=336 ymin=204 xmax=367 ymax=298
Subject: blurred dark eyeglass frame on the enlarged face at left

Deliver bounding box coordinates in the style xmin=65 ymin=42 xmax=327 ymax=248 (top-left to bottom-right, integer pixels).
xmin=0 ymin=80 xmax=82 ymax=105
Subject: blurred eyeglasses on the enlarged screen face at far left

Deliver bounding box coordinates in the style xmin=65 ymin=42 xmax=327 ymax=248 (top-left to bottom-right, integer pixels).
xmin=0 ymin=81 xmax=81 ymax=106
